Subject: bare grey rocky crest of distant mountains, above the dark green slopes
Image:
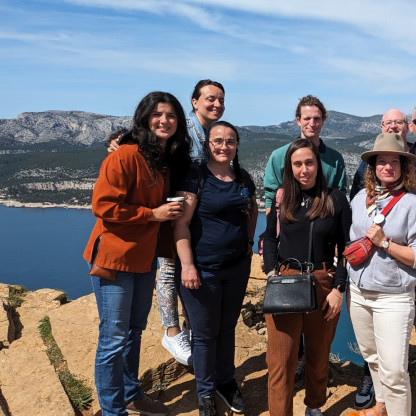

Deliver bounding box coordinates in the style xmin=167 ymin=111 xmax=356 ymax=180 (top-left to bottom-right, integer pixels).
xmin=0 ymin=110 xmax=381 ymax=146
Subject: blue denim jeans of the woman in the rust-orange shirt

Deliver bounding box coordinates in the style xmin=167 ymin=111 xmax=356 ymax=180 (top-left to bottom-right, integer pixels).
xmin=91 ymin=257 xmax=157 ymax=416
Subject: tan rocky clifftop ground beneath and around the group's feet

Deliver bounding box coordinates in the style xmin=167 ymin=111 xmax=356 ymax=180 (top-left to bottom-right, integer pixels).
xmin=0 ymin=257 xmax=416 ymax=416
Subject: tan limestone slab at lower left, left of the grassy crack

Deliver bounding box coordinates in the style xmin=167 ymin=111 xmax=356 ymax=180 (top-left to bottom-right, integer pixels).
xmin=0 ymin=289 xmax=75 ymax=416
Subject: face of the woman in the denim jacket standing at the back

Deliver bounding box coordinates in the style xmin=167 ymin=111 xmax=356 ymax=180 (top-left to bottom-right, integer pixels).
xmin=192 ymin=85 xmax=225 ymax=129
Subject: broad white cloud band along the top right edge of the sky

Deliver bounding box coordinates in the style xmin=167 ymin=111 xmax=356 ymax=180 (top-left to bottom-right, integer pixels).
xmin=30 ymin=0 xmax=416 ymax=60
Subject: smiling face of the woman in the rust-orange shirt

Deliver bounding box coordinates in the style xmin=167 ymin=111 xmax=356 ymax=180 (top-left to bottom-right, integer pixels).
xmin=148 ymin=103 xmax=178 ymax=146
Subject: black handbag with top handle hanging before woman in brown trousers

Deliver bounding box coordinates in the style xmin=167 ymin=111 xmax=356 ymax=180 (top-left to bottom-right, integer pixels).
xmin=263 ymin=221 xmax=318 ymax=314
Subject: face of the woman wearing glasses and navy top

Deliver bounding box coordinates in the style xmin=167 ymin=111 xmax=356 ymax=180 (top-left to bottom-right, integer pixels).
xmin=209 ymin=126 xmax=238 ymax=164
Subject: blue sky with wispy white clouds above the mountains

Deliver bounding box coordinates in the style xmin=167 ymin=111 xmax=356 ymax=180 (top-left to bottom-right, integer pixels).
xmin=0 ymin=0 xmax=416 ymax=126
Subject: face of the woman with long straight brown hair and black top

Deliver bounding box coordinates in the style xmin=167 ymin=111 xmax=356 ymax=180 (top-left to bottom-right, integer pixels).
xmin=290 ymin=147 xmax=318 ymax=190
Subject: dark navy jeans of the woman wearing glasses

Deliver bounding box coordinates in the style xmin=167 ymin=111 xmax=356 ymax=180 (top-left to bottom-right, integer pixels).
xmin=177 ymin=257 xmax=251 ymax=397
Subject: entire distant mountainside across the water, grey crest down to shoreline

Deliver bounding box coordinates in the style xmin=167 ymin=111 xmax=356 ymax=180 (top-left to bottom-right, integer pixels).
xmin=0 ymin=111 xmax=413 ymax=205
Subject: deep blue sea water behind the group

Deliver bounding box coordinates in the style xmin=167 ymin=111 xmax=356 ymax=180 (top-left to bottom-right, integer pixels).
xmin=0 ymin=205 xmax=362 ymax=364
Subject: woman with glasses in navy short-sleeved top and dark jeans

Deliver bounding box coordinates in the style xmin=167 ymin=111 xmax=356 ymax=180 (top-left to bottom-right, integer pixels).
xmin=175 ymin=121 xmax=257 ymax=416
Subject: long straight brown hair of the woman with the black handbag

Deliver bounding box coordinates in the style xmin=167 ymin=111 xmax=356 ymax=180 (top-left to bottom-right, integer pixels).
xmin=279 ymin=139 xmax=334 ymax=223
